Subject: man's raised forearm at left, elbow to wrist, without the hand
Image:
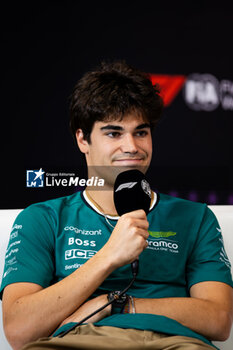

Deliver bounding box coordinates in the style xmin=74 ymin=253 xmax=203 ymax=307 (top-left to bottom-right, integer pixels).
xmin=4 ymin=250 xmax=116 ymax=348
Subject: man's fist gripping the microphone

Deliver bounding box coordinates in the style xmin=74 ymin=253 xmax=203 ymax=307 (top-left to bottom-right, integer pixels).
xmin=102 ymin=210 xmax=149 ymax=268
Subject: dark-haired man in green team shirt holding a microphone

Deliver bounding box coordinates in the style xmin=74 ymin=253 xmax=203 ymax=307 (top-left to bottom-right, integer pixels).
xmin=1 ymin=62 xmax=233 ymax=350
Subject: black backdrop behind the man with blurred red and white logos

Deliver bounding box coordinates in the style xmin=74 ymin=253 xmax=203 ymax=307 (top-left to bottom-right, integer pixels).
xmin=0 ymin=1 xmax=233 ymax=208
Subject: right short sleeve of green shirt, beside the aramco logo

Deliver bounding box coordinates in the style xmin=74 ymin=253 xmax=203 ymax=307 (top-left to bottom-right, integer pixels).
xmin=187 ymin=206 xmax=233 ymax=288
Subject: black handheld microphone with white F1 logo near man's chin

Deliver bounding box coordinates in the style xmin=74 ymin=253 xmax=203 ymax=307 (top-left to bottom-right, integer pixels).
xmin=114 ymin=169 xmax=151 ymax=277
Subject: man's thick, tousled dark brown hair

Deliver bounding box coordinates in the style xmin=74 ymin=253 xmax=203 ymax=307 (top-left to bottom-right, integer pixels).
xmin=70 ymin=61 xmax=163 ymax=143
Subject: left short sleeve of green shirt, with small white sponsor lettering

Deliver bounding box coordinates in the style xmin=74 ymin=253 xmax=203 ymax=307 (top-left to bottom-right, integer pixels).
xmin=0 ymin=204 xmax=55 ymax=297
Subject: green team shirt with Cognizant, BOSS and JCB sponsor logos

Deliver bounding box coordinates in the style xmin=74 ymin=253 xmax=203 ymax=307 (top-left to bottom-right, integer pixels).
xmin=1 ymin=193 xmax=233 ymax=343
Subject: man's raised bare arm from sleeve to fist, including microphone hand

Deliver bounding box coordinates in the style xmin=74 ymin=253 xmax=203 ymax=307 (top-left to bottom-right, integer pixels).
xmin=3 ymin=210 xmax=149 ymax=348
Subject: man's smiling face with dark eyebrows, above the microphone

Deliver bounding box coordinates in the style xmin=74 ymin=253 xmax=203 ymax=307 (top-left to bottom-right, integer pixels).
xmin=77 ymin=114 xmax=152 ymax=185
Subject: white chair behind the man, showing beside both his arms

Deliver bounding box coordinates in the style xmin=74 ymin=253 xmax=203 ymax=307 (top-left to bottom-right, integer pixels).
xmin=0 ymin=205 xmax=233 ymax=350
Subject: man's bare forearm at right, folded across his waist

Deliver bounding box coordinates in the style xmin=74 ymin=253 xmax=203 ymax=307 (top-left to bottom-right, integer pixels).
xmin=134 ymin=297 xmax=231 ymax=341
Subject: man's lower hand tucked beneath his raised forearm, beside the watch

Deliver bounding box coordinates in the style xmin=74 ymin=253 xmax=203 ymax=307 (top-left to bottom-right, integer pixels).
xmin=58 ymin=294 xmax=111 ymax=328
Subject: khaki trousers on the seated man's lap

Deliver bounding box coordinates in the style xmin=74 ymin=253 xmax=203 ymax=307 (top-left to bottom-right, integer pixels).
xmin=22 ymin=323 xmax=215 ymax=350
